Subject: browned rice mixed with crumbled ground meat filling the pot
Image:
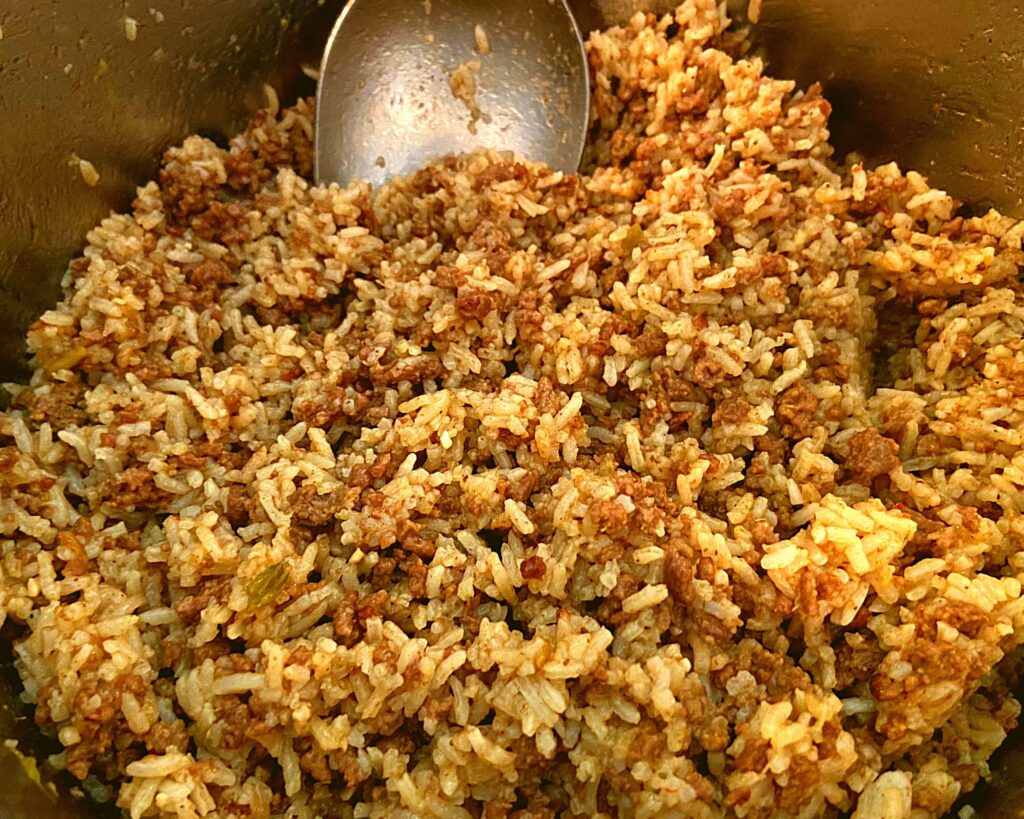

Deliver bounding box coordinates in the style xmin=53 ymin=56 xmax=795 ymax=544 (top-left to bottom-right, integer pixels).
xmin=0 ymin=0 xmax=1024 ymax=819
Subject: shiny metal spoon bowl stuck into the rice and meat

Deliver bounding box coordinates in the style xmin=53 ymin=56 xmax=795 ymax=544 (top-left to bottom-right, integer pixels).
xmin=316 ymin=0 xmax=590 ymax=185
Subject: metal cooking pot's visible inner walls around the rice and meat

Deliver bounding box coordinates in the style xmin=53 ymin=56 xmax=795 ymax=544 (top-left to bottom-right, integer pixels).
xmin=0 ymin=0 xmax=1024 ymax=819
